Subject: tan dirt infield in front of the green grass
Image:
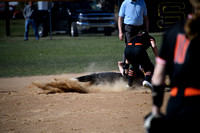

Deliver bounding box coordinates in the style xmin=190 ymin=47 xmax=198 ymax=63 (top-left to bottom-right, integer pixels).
xmin=0 ymin=74 xmax=169 ymax=133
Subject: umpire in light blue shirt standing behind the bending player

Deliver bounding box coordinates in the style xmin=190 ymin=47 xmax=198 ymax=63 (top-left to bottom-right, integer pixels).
xmin=118 ymin=0 xmax=149 ymax=44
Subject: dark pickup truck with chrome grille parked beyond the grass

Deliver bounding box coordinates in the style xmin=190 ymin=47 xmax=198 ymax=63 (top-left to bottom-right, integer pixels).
xmin=37 ymin=1 xmax=115 ymax=37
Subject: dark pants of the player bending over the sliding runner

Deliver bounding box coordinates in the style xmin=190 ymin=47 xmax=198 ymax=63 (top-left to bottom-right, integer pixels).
xmin=124 ymin=44 xmax=154 ymax=86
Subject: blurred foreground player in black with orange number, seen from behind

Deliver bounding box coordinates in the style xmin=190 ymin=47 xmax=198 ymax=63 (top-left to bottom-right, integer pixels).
xmin=144 ymin=0 xmax=200 ymax=133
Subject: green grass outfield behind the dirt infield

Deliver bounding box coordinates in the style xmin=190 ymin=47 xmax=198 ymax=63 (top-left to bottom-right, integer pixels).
xmin=0 ymin=20 xmax=162 ymax=77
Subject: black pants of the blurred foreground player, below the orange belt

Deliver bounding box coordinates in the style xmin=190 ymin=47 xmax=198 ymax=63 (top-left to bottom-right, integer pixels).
xmin=166 ymin=88 xmax=200 ymax=133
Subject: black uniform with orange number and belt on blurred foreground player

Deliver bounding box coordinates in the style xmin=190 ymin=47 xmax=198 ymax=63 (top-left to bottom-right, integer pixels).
xmin=158 ymin=22 xmax=200 ymax=133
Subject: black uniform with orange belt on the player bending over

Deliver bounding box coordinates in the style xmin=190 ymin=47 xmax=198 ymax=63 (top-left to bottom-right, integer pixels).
xmin=124 ymin=34 xmax=155 ymax=86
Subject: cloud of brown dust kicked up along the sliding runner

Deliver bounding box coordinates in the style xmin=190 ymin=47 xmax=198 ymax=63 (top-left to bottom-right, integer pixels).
xmin=32 ymin=76 xmax=146 ymax=94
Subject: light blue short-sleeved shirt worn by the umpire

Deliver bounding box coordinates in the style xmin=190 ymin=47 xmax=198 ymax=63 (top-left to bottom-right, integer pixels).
xmin=119 ymin=0 xmax=147 ymax=26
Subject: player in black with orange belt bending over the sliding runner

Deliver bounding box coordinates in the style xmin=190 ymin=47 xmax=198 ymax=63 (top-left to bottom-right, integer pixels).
xmin=124 ymin=30 xmax=158 ymax=88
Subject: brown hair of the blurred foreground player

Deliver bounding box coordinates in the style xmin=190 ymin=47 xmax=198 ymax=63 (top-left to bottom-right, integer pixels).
xmin=184 ymin=15 xmax=200 ymax=40
